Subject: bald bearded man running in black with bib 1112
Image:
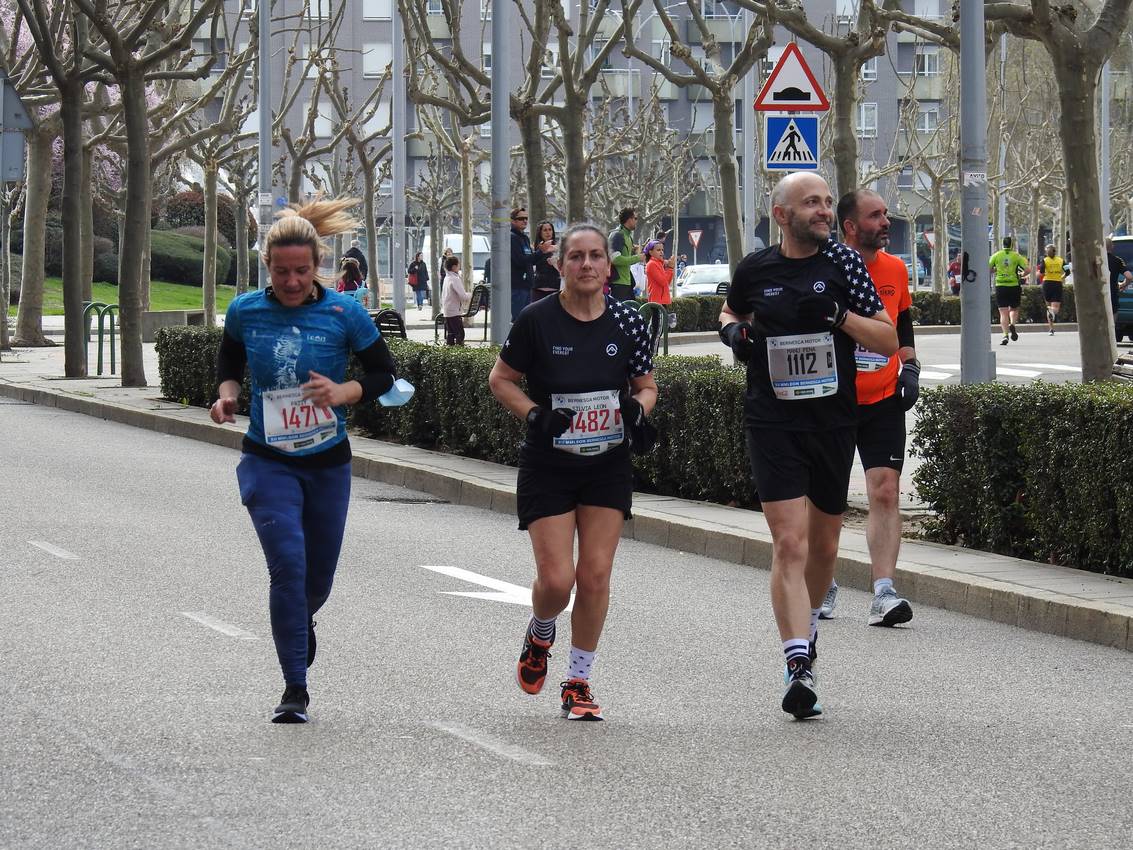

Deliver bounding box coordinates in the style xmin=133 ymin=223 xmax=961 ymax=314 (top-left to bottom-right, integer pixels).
xmin=719 ymin=172 xmax=897 ymax=720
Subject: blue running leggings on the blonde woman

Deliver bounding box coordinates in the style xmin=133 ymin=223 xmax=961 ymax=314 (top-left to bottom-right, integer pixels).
xmin=236 ymin=454 xmax=350 ymax=686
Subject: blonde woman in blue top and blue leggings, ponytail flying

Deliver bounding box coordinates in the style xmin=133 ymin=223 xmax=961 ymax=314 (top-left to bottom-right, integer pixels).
xmin=210 ymin=198 xmax=394 ymax=723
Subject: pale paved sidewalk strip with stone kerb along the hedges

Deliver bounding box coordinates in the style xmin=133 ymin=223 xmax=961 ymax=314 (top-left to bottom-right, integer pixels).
xmin=0 ymin=335 xmax=1133 ymax=651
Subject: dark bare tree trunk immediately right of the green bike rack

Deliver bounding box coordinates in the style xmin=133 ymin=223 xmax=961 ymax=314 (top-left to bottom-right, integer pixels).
xmin=118 ymin=73 xmax=150 ymax=386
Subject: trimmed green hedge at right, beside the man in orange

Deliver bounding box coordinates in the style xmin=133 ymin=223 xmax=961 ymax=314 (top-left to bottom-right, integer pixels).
xmin=912 ymin=382 xmax=1133 ymax=576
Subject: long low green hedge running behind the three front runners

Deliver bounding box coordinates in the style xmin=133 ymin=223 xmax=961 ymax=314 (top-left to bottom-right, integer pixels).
xmin=156 ymin=328 xmax=755 ymax=505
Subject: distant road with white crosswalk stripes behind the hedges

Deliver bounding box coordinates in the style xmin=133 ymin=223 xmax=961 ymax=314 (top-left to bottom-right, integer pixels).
xmin=668 ymin=329 xmax=1114 ymax=386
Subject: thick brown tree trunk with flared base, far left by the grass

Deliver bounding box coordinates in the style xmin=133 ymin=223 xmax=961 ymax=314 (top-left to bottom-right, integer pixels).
xmin=15 ymin=129 xmax=56 ymax=346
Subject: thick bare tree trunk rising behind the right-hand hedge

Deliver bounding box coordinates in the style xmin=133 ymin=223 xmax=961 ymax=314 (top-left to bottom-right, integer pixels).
xmin=1055 ymin=74 xmax=1117 ymax=381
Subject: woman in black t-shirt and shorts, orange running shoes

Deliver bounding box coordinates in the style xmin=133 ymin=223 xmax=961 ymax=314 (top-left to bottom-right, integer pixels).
xmin=488 ymin=224 xmax=657 ymax=720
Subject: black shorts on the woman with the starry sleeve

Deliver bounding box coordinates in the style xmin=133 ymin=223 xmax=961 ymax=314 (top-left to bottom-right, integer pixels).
xmin=516 ymin=453 xmax=633 ymax=532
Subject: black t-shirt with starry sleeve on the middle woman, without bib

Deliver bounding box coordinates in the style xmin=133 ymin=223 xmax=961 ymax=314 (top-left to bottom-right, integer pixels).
xmin=500 ymin=296 xmax=653 ymax=466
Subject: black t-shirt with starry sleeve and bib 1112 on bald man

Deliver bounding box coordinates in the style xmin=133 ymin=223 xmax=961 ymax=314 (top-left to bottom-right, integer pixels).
xmin=727 ymin=240 xmax=885 ymax=431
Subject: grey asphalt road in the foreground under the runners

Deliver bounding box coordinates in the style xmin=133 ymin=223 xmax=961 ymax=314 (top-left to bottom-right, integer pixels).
xmin=0 ymin=401 xmax=1133 ymax=849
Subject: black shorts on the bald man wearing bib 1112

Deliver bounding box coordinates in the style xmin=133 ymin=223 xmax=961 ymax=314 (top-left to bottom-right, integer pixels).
xmin=747 ymin=427 xmax=854 ymax=516
